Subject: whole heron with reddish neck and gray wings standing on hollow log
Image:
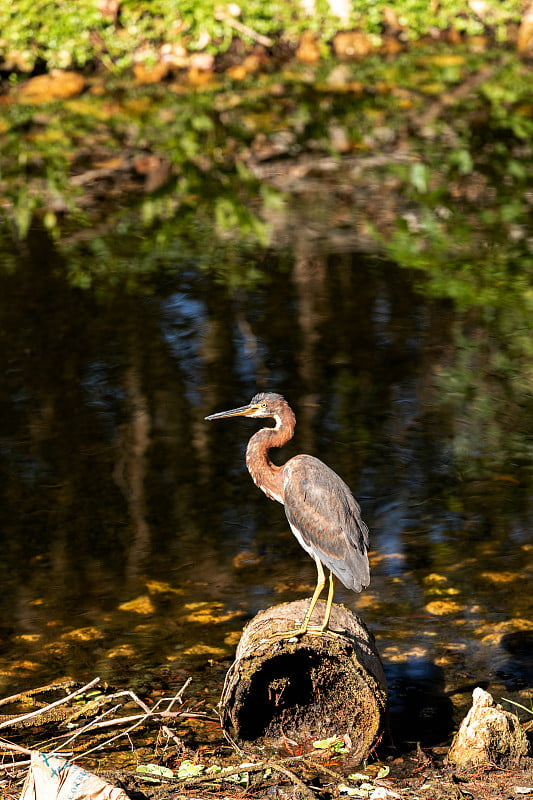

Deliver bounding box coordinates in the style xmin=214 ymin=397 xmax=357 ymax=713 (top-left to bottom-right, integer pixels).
xmin=205 ymin=392 xmax=370 ymax=636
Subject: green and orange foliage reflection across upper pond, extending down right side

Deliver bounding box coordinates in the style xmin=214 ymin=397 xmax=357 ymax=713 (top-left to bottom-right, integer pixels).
xmin=2 ymin=48 xmax=533 ymax=482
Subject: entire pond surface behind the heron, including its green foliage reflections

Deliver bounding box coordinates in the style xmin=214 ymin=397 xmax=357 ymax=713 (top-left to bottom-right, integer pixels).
xmin=0 ymin=40 xmax=533 ymax=748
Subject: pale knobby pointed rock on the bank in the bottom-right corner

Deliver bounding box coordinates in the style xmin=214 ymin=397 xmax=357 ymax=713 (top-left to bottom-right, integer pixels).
xmin=448 ymin=687 xmax=529 ymax=768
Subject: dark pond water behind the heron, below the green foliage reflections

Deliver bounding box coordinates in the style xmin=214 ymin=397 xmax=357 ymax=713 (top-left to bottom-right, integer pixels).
xmin=0 ymin=223 xmax=533 ymax=744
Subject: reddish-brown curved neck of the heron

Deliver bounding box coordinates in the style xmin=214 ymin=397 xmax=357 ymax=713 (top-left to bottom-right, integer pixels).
xmin=246 ymin=406 xmax=296 ymax=503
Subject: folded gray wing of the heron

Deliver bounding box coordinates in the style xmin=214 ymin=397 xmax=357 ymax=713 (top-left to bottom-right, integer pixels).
xmin=283 ymin=455 xmax=370 ymax=592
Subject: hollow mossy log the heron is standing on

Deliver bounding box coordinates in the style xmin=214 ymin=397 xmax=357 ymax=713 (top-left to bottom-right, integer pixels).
xmin=221 ymin=600 xmax=387 ymax=762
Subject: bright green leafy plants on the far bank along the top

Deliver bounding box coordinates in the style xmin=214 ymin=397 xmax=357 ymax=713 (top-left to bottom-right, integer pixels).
xmin=0 ymin=0 xmax=521 ymax=73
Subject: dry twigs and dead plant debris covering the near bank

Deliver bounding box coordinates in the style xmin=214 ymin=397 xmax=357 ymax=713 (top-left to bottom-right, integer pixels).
xmin=0 ymin=678 xmax=533 ymax=800
